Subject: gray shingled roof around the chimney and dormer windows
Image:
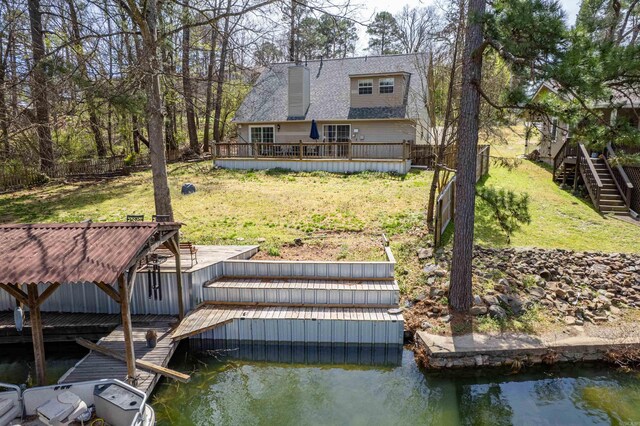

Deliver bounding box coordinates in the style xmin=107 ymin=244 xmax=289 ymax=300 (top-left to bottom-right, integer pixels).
xmin=234 ymin=53 xmax=427 ymax=122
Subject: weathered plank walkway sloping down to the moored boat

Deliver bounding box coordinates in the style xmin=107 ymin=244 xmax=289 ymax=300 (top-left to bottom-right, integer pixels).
xmin=58 ymin=319 xmax=178 ymax=395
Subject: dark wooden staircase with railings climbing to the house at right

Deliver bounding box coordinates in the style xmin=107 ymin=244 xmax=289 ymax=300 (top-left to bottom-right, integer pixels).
xmin=553 ymin=139 xmax=633 ymax=216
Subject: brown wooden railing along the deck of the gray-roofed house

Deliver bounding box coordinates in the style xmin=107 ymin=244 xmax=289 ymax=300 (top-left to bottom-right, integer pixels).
xmin=213 ymin=142 xmax=410 ymax=160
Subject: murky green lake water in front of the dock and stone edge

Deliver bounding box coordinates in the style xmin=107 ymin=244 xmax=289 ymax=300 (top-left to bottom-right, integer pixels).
xmin=0 ymin=345 xmax=640 ymax=426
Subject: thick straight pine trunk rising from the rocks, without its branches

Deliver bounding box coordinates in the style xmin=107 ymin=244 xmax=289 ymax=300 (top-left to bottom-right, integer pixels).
xmin=449 ymin=0 xmax=486 ymax=311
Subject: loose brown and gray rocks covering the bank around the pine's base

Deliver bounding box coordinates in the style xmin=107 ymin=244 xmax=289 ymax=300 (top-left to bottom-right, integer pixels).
xmin=414 ymin=247 xmax=640 ymax=325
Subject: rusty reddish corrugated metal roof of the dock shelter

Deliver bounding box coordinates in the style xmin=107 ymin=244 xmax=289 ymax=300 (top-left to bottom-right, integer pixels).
xmin=0 ymin=222 xmax=180 ymax=284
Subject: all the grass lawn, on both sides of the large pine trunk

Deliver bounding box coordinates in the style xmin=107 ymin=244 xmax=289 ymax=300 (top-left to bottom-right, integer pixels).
xmin=0 ymin=130 xmax=640 ymax=269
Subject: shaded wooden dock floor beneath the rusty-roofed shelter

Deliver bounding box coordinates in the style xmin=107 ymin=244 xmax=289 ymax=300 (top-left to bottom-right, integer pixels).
xmin=0 ymin=311 xmax=176 ymax=345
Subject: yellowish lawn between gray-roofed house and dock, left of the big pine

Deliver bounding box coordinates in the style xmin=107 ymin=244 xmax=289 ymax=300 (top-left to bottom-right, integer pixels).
xmin=0 ymin=166 xmax=431 ymax=260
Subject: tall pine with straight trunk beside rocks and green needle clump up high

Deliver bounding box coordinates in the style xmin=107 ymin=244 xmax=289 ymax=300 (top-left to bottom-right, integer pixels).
xmin=449 ymin=0 xmax=564 ymax=311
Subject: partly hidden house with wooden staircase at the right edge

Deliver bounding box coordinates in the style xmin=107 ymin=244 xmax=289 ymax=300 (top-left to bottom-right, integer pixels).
xmin=530 ymin=81 xmax=640 ymax=218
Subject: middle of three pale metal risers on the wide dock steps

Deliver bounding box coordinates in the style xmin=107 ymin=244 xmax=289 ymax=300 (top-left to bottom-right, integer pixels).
xmin=203 ymin=285 xmax=400 ymax=306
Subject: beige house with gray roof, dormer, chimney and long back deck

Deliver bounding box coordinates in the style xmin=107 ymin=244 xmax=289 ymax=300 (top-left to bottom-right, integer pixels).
xmin=214 ymin=54 xmax=429 ymax=173
